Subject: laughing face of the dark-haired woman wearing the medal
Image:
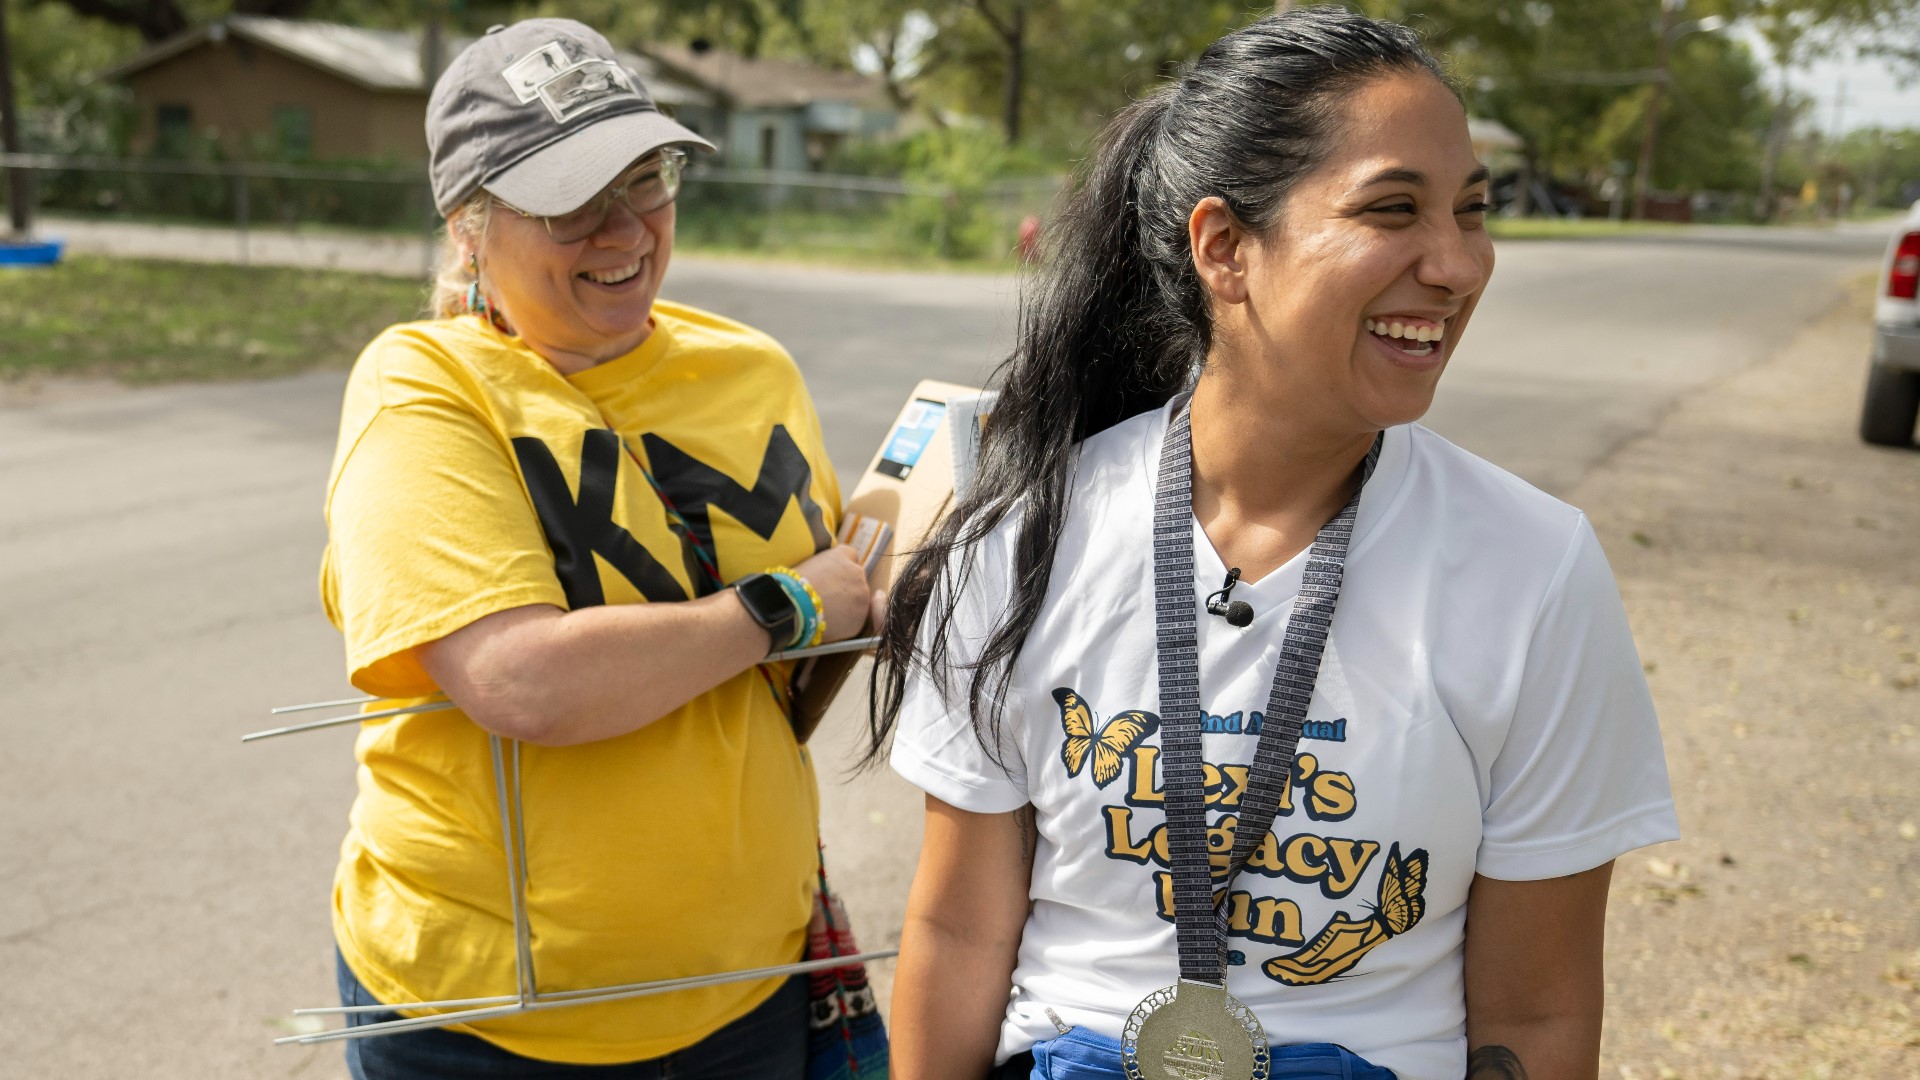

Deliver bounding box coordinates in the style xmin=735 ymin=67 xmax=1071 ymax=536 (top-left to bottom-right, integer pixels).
xmin=1192 ymin=73 xmax=1494 ymax=432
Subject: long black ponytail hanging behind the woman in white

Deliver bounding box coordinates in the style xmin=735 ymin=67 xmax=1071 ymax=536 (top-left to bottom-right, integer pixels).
xmin=868 ymin=96 xmax=1187 ymax=759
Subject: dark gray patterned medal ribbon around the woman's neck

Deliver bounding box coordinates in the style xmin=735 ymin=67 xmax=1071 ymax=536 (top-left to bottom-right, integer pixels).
xmin=1154 ymin=400 xmax=1382 ymax=986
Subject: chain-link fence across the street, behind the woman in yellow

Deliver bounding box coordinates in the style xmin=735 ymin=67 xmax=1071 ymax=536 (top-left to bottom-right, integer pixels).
xmin=0 ymin=154 xmax=1060 ymax=265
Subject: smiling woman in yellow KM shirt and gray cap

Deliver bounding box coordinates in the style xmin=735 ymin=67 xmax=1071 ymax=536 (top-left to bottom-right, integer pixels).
xmin=321 ymin=19 xmax=874 ymax=1080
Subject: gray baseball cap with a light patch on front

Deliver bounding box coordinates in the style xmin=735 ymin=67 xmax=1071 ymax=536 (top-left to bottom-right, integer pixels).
xmin=426 ymin=19 xmax=714 ymax=215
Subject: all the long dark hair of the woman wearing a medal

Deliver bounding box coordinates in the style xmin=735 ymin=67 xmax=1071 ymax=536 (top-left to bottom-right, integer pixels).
xmin=868 ymin=8 xmax=1446 ymax=761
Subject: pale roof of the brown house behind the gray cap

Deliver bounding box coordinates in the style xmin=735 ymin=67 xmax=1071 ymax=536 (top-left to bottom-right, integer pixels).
xmin=102 ymin=15 xmax=710 ymax=106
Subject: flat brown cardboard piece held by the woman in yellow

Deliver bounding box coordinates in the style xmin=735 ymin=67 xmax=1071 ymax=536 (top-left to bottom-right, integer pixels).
xmin=793 ymin=379 xmax=996 ymax=742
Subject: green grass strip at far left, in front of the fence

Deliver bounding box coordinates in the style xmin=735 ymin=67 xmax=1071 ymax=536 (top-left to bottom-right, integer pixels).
xmin=0 ymin=256 xmax=426 ymax=382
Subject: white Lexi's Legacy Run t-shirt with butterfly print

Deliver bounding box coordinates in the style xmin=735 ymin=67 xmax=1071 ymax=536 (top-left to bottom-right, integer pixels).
xmin=893 ymin=397 xmax=1678 ymax=1080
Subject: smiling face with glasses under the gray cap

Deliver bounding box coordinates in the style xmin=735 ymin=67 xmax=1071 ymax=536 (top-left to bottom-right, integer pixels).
xmin=480 ymin=156 xmax=674 ymax=375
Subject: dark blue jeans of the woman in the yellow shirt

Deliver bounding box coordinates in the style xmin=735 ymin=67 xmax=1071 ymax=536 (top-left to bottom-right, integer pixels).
xmin=334 ymin=957 xmax=806 ymax=1080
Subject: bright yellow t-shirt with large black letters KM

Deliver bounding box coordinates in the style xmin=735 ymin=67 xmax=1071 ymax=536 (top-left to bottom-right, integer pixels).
xmin=321 ymin=302 xmax=841 ymax=1065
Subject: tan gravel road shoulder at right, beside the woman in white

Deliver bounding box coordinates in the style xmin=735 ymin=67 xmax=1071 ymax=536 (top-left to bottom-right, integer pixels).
xmin=1567 ymin=282 xmax=1920 ymax=1080
